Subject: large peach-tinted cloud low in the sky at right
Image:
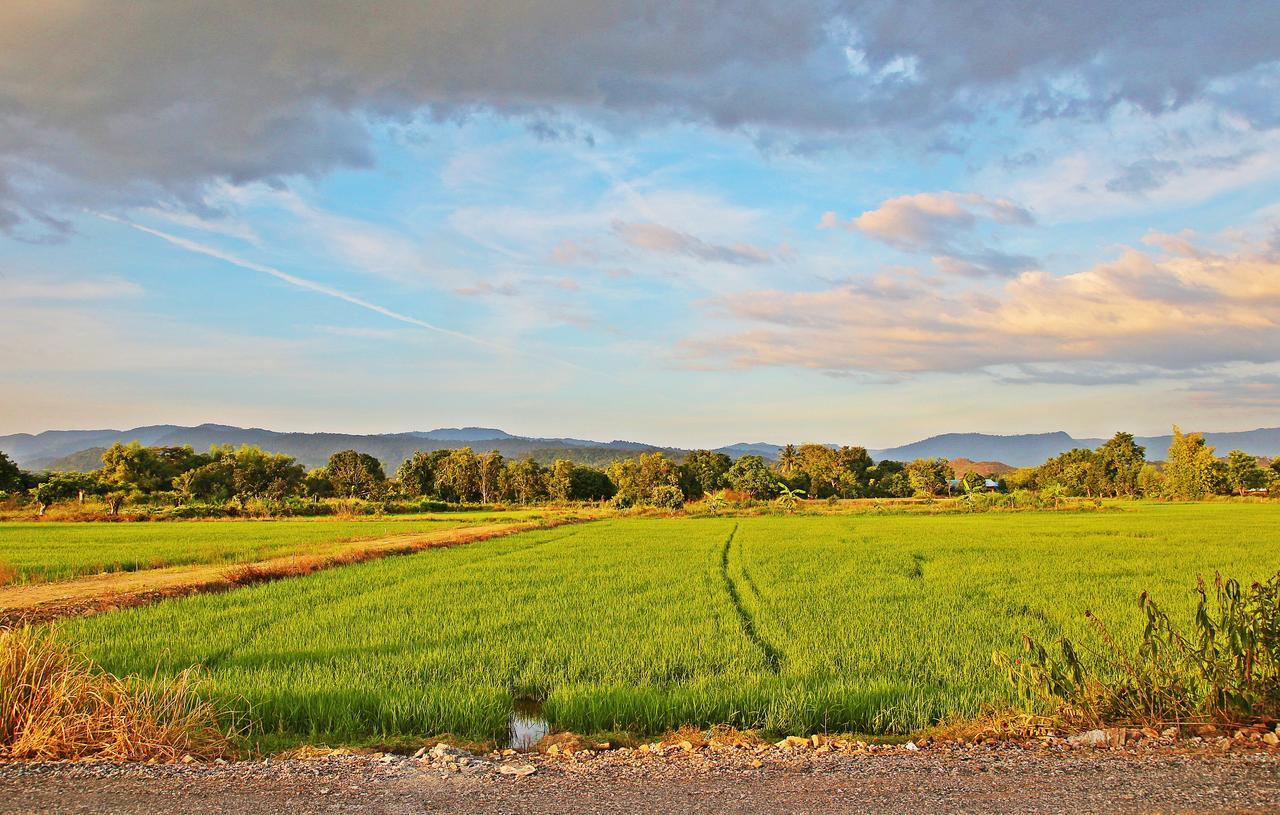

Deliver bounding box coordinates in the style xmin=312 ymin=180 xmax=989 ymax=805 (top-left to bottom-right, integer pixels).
xmin=684 ymin=227 xmax=1280 ymax=377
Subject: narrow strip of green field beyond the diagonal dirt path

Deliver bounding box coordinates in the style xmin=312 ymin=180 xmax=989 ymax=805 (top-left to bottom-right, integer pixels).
xmin=0 ymin=512 xmax=545 ymax=585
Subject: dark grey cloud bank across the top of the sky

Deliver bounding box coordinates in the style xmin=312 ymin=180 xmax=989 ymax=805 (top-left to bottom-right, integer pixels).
xmin=0 ymin=0 xmax=1280 ymax=231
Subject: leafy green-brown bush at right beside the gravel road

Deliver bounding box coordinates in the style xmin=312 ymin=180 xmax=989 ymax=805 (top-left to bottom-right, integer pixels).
xmin=996 ymin=574 xmax=1280 ymax=727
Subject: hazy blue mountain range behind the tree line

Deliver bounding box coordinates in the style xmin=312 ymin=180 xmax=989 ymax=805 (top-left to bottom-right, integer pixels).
xmin=0 ymin=425 xmax=1280 ymax=470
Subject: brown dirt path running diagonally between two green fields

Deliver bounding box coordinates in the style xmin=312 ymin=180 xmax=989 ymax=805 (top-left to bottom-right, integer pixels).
xmin=0 ymin=517 xmax=590 ymax=627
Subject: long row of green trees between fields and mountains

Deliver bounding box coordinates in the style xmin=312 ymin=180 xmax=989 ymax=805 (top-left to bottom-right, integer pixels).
xmin=0 ymin=426 xmax=1280 ymax=514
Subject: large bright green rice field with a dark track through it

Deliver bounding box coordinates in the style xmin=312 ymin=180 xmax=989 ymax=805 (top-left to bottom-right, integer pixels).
xmin=52 ymin=504 xmax=1280 ymax=743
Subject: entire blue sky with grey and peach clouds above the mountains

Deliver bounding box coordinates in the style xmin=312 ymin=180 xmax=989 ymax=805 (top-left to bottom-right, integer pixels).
xmin=0 ymin=0 xmax=1280 ymax=447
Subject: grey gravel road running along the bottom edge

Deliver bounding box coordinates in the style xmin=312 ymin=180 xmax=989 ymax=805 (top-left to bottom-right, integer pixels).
xmin=0 ymin=750 xmax=1280 ymax=815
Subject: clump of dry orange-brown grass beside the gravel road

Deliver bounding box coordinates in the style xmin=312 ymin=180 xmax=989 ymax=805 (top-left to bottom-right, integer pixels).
xmin=0 ymin=628 xmax=233 ymax=761
